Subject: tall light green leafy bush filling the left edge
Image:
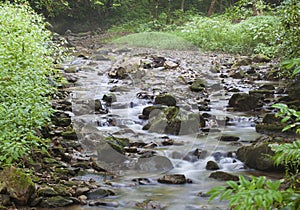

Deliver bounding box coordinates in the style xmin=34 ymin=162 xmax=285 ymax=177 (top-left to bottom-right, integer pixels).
xmin=0 ymin=1 xmax=54 ymax=165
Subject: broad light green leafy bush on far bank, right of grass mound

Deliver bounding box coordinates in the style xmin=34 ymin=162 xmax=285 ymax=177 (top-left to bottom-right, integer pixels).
xmin=181 ymin=16 xmax=280 ymax=57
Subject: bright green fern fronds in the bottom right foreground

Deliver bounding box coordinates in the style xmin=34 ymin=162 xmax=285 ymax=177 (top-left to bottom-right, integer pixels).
xmin=208 ymin=176 xmax=284 ymax=210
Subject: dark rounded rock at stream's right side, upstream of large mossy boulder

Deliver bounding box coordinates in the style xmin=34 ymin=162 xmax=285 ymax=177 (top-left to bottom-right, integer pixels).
xmin=229 ymin=93 xmax=260 ymax=111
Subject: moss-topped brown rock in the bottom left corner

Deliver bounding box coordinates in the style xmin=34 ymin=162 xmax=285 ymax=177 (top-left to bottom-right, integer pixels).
xmin=0 ymin=166 xmax=35 ymax=206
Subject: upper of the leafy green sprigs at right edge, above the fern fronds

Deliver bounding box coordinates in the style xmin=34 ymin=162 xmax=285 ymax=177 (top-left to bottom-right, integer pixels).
xmin=272 ymin=103 xmax=300 ymax=133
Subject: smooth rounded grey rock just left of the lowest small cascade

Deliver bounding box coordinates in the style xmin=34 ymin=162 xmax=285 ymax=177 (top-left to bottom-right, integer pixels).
xmin=135 ymin=156 xmax=173 ymax=172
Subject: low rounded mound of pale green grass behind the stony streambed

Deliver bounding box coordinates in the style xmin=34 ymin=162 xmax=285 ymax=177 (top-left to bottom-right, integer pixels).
xmin=113 ymin=32 xmax=196 ymax=50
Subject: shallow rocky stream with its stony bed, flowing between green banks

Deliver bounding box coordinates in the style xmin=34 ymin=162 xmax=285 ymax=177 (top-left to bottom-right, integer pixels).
xmin=59 ymin=46 xmax=282 ymax=210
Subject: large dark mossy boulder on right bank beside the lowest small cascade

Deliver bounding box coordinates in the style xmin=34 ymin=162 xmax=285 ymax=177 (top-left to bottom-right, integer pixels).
xmin=236 ymin=143 xmax=282 ymax=171
